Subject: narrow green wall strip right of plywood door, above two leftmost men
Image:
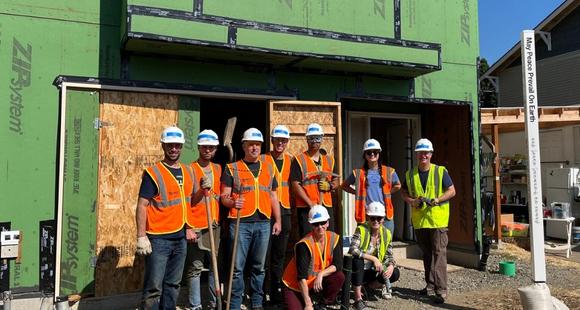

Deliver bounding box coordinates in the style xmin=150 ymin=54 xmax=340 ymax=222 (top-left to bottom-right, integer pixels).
xmin=177 ymin=96 xmax=200 ymax=164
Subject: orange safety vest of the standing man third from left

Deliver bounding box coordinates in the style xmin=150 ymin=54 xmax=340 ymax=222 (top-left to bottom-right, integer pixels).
xmin=227 ymin=160 xmax=274 ymax=218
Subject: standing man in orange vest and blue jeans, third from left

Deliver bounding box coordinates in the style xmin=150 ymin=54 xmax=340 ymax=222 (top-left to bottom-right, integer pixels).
xmin=221 ymin=128 xmax=280 ymax=310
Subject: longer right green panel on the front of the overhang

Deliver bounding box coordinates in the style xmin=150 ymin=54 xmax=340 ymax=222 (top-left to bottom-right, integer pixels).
xmin=237 ymin=28 xmax=439 ymax=66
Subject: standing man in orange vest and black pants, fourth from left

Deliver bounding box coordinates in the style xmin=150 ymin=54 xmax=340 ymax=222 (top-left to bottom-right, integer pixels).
xmin=263 ymin=125 xmax=293 ymax=305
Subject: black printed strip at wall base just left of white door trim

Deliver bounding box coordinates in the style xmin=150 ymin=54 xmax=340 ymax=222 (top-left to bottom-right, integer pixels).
xmin=38 ymin=220 xmax=56 ymax=293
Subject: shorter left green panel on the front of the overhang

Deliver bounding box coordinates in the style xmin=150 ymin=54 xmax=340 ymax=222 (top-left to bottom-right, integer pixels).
xmin=130 ymin=15 xmax=228 ymax=43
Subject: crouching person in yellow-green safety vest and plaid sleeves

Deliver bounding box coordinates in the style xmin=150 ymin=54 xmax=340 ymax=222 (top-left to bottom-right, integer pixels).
xmin=349 ymin=202 xmax=399 ymax=310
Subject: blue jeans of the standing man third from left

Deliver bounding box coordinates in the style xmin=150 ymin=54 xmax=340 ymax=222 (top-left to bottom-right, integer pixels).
xmin=230 ymin=220 xmax=270 ymax=310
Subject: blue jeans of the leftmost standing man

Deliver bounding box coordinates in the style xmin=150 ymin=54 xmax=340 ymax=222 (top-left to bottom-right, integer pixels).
xmin=141 ymin=238 xmax=187 ymax=310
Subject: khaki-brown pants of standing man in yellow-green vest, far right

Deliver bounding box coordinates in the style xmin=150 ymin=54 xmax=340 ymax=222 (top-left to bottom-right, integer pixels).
xmin=415 ymin=228 xmax=449 ymax=295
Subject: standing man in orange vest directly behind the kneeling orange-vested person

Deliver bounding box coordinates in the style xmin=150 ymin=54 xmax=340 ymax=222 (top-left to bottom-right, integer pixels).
xmin=290 ymin=123 xmax=339 ymax=236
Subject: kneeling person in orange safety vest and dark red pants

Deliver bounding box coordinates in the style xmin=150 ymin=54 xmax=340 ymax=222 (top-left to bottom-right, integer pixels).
xmin=282 ymin=205 xmax=344 ymax=310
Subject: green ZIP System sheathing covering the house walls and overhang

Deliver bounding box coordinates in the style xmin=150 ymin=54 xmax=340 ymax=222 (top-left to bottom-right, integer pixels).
xmin=0 ymin=0 xmax=480 ymax=292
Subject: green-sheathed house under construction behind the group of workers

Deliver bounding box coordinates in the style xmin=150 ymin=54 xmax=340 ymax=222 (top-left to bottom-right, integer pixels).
xmin=0 ymin=0 xmax=481 ymax=302
